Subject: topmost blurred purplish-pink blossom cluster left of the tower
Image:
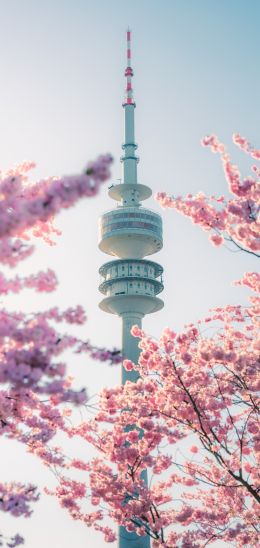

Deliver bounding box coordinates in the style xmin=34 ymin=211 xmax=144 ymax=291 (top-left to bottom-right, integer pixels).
xmin=0 ymin=154 xmax=112 ymax=266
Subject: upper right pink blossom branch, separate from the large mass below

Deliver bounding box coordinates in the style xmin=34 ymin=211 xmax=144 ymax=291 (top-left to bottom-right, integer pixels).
xmin=156 ymin=134 xmax=260 ymax=256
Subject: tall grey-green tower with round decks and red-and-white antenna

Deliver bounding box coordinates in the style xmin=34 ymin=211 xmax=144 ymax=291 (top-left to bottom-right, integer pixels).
xmin=99 ymin=30 xmax=163 ymax=548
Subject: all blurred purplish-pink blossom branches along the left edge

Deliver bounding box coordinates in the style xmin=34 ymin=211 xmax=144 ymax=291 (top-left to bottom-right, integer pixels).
xmin=0 ymin=155 xmax=120 ymax=547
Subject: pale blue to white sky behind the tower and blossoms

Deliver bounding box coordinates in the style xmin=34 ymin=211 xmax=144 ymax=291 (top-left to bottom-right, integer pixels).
xmin=0 ymin=0 xmax=260 ymax=548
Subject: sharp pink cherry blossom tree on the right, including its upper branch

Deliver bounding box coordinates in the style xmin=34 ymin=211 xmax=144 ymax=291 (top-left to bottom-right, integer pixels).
xmin=45 ymin=136 xmax=260 ymax=548
